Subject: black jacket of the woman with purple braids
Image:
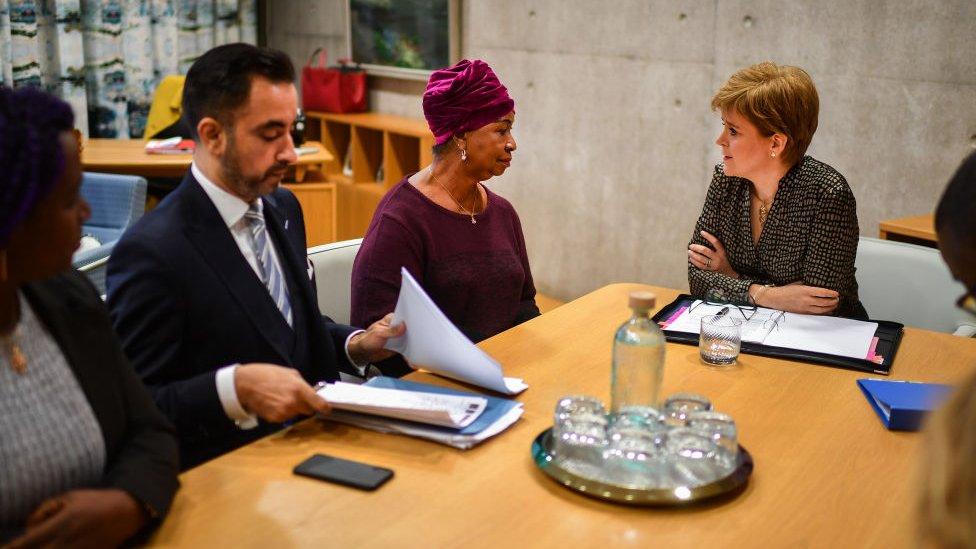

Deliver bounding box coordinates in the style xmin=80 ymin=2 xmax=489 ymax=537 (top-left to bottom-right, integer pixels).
xmin=22 ymin=271 xmax=179 ymax=536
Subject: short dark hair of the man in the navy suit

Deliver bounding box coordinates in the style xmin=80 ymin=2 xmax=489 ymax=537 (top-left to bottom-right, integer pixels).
xmin=183 ymin=43 xmax=295 ymax=140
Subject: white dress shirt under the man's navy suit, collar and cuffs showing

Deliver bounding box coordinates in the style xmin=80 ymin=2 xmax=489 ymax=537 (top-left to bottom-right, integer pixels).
xmin=190 ymin=162 xmax=369 ymax=429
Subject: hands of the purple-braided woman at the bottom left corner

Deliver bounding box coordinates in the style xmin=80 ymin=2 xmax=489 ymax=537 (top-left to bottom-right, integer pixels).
xmin=9 ymin=490 xmax=148 ymax=549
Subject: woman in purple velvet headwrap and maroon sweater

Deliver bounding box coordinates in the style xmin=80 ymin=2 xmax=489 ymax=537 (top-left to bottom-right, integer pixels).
xmin=351 ymin=59 xmax=539 ymax=342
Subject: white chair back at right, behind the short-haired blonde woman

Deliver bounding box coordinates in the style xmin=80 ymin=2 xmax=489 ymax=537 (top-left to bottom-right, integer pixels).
xmin=855 ymin=236 xmax=976 ymax=337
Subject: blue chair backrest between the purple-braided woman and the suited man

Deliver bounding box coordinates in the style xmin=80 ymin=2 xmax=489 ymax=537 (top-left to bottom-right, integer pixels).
xmin=81 ymin=172 xmax=146 ymax=244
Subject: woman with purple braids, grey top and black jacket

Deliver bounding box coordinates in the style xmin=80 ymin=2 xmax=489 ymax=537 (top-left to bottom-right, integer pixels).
xmin=0 ymin=87 xmax=178 ymax=547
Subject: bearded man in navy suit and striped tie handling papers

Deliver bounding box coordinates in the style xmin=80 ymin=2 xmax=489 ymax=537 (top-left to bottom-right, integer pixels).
xmin=106 ymin=44 xmax=403 ymax=467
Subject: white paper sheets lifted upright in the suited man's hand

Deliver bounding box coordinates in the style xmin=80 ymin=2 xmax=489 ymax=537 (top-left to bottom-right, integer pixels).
xmin=386 ymin=268 xmax=529 ymax=395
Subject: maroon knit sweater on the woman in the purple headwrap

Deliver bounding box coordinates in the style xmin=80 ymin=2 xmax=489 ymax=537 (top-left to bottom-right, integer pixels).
xmin=351 ymin=178 xmax=539 ymax=342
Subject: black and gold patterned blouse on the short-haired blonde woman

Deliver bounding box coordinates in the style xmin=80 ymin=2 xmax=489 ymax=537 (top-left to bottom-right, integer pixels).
xmin=688 ymin=156 xmax=867 ymax=318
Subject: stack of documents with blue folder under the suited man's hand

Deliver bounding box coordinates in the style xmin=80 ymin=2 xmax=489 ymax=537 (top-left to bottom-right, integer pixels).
xmin=319 ymin=377 xmax=523 ymax=449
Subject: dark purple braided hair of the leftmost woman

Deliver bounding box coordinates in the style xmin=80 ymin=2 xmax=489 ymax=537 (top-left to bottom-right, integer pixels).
xmin=0 ymin=86 xmax=74 ymax=246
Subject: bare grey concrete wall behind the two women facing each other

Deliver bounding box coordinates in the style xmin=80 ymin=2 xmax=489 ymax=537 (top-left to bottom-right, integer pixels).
xmin=269 ymin=0 xmax=976 ymax=299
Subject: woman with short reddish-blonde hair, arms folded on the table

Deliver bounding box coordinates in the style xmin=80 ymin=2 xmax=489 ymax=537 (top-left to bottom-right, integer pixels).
xmin=688 ymin=62 xmax=867 ymax=318
